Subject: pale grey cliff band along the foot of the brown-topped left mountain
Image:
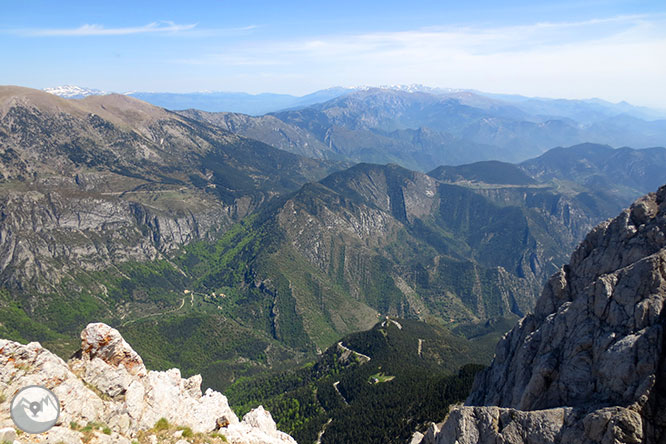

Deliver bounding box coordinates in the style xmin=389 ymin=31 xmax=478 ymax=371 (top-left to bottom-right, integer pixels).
xmin=0 ymin=179 xmax=227 ymax=291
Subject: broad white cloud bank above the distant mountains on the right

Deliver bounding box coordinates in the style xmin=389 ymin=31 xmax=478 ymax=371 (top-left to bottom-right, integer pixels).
xmin=181 ymin=16 xmax=666 ymax=108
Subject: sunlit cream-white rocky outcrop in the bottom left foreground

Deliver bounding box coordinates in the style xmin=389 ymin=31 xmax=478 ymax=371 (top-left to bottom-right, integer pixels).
xmin=0 ymin=323 xmax=295 ymax=444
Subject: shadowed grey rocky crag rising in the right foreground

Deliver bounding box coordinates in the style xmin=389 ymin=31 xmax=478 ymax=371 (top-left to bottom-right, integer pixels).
xmin=416 ymin=186 xmax=666 ymax=444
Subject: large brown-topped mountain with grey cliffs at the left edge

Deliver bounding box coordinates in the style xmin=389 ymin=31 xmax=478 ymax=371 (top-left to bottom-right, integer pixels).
xmin=0 ymin=86 xmax=340 ymax=292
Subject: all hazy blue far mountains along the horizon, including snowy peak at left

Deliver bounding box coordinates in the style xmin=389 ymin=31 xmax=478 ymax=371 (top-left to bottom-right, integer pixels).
xmin=45 ymin=85 xmax=666 ymax=171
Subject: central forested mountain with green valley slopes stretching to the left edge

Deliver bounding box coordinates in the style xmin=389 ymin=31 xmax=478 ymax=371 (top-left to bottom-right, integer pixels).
xmin=3 ymin=149 xmax=616 ymax=389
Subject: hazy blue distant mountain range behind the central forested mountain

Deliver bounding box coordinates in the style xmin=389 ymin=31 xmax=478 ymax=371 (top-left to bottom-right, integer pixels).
xmin=181 ymin=88 xmax=666 ymax=171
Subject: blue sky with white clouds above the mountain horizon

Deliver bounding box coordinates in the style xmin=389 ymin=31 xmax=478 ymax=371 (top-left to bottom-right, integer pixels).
xmin=0 ymin=0 xmax=666 ymax=109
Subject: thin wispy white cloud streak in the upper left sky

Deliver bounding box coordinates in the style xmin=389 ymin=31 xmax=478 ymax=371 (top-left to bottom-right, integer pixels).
xmin=14 ymin=22 xmax=197 ymax=37
